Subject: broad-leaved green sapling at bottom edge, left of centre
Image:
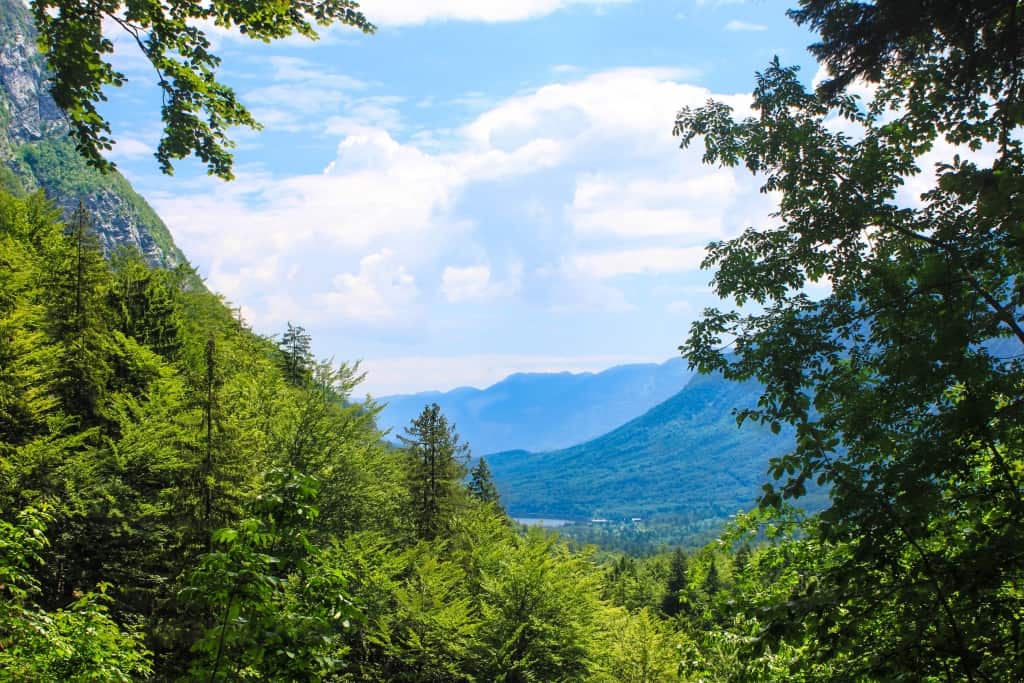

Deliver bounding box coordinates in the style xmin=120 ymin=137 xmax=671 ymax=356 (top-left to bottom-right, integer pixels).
xmin=186 ymin=470 xmax=359 ymax=681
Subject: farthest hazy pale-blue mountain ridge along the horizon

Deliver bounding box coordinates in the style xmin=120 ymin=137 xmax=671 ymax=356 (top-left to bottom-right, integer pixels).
xmin=379 ymin=358 xmax=691 ymax=455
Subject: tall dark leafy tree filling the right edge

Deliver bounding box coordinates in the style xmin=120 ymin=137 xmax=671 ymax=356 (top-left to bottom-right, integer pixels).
xmin=676 ymin=0 xmax=1024 ymax=680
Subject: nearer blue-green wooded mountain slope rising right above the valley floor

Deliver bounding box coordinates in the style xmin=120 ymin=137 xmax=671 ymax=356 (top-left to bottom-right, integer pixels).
xmin=486 ymin=368 xmax=823 ymax=524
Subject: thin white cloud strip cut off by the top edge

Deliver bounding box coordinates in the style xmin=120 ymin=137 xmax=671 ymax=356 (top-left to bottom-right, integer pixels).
xmin=360 ymin=0 xmax=630 ymax=26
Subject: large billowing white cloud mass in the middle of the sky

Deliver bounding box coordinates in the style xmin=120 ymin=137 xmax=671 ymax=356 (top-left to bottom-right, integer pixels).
xmin=153 ymin=66 xmax=772 ymax=352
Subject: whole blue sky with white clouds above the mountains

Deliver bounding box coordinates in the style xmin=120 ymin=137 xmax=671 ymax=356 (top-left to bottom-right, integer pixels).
xmin=96 ymin=0 xmax=817 ymax=396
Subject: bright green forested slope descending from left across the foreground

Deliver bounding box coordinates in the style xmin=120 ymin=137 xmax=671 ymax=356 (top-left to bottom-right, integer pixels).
xmin=0 ymin=185 xmax=819 ymax=683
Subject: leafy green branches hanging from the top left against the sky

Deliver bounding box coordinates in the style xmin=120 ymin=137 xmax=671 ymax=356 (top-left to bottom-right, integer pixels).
xmin=32 ymin=0 xmax=374 ymax=179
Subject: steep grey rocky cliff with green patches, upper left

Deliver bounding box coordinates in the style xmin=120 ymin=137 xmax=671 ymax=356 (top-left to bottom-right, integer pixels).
xmin=0 ymin=0 xmax=186 ymax=267
